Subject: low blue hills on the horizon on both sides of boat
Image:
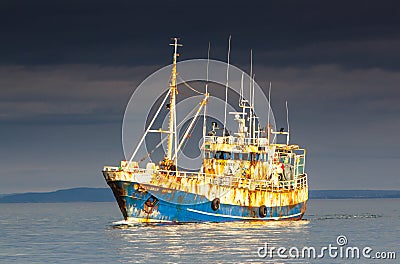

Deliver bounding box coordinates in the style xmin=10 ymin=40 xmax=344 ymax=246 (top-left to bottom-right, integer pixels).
xmin=0 ymin=188 xmax=400 ymax=203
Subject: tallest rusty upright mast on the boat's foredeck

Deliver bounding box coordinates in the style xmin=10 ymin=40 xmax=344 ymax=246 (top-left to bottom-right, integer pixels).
xmin=167 ymin=38 xmax=182 ymax=163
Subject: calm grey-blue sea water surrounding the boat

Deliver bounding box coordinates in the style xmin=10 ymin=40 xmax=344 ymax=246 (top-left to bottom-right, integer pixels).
xmin=0 ymin=199 xmax=400 ymax=263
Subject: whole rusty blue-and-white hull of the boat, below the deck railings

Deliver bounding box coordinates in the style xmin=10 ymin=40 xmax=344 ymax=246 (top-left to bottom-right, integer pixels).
xmin=103 ymin=168 xmax=308 ymax=223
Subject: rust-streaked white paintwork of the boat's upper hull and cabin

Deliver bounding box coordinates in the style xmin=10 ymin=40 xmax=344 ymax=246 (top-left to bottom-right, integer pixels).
xmin=103 ymin=140 xmax=308 ymax=215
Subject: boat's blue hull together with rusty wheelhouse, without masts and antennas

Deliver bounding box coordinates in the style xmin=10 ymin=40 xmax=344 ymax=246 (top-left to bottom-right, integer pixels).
xmin=103 ymin=138 xmax=308 ymax=222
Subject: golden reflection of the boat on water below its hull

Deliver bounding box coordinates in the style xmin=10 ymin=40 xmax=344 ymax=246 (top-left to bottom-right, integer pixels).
xmin=111 ymin=220 xmax=309 ymax=262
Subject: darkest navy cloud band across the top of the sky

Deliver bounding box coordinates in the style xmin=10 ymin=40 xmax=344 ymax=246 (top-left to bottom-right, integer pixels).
xmin=0 ymin=0 xmax=400 ymax=69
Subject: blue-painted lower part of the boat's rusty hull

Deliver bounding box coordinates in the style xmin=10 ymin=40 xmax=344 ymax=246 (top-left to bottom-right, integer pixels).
xmin=108 ymin=181 xmax=306 ymax=222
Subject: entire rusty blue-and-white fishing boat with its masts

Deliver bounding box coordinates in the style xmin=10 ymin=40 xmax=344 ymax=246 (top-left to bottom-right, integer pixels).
xmin=102 ymin=38 xmax=308 ymax=223
